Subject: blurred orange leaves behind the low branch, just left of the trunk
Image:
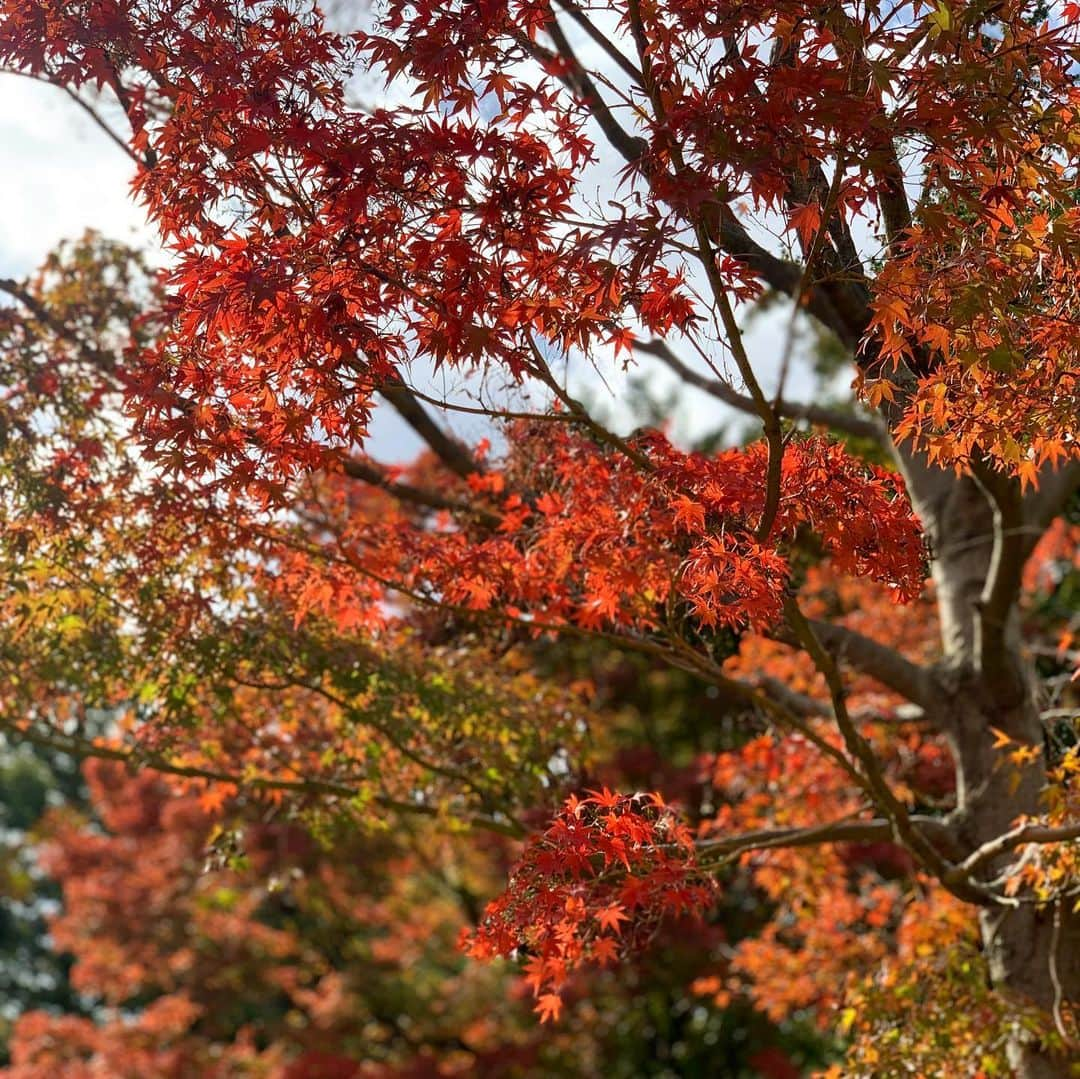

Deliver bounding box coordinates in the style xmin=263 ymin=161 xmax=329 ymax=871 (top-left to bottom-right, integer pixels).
xmin=698 ymin=724 xmax=913 ymax=1025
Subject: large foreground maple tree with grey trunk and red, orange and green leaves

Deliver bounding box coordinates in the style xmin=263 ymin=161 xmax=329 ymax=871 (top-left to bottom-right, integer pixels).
xmin=0 ymin=0 xmax=1080 ymax=1079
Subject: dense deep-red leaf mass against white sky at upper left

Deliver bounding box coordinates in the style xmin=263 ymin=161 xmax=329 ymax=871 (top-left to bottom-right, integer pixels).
xmin=0 ymin=0 xmax=690 ymax=497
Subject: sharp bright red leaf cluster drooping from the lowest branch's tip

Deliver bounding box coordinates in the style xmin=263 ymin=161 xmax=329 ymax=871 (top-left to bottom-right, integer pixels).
xmin=463 ymin=787 xmax=715 ymax=1021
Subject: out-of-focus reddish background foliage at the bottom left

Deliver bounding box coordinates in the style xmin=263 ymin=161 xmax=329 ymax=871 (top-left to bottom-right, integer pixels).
xmin=8 ymin=761 xmax=565 ymax=1079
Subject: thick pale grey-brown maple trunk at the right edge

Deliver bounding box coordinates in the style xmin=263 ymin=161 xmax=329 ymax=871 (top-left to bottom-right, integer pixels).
xmin=897 ymin=460 xmax=1080 ymax=1079
